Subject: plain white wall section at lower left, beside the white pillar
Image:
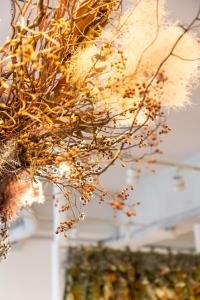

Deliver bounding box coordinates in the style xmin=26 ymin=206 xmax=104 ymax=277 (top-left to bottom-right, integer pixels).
xmin=0 ymin=239 xmax=51 ymax=300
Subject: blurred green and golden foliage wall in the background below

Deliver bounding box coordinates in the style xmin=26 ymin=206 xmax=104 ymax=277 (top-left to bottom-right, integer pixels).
xmin=64 ymin=247 xmax=200 ymax=300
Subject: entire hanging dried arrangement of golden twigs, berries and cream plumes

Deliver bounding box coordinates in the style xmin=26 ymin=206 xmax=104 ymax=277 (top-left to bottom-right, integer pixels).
xmin=0 ymin=0 xmax=200 ymax=258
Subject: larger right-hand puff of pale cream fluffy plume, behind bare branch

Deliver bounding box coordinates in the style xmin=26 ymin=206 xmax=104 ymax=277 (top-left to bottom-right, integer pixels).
xmin=119 ymin=0 xmax=200 ymax=107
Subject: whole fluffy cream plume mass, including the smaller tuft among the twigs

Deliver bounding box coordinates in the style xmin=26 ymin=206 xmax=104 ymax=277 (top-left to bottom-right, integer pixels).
xmin=75 ymin=0 xmax=200 ymax=115
